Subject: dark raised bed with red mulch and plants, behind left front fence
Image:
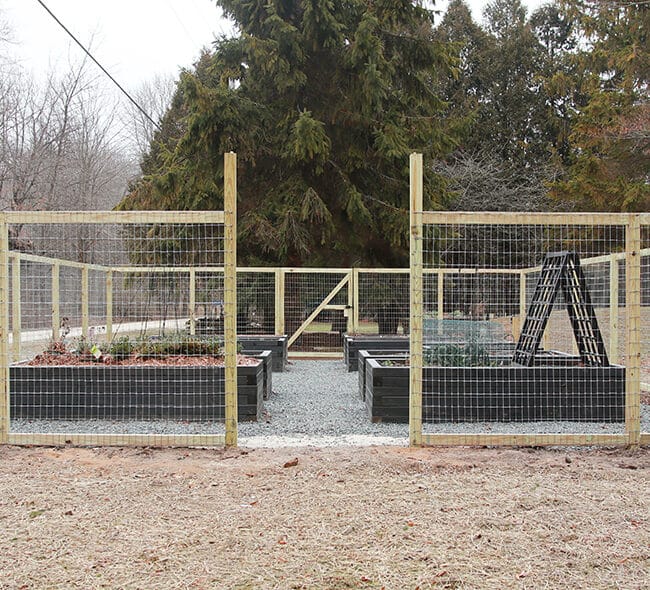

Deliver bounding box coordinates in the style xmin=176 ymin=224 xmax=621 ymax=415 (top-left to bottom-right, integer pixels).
xmin=9 ymin=337 xmax=270 ymax=421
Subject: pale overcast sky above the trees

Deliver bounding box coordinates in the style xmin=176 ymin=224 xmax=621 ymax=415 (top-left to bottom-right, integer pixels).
xmin=0 ymin=0 xmax=543 ymax=88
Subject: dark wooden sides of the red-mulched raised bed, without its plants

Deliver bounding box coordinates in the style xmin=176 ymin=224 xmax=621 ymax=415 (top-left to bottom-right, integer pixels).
xmin=9 ymin=361 xmax=264 ymax=421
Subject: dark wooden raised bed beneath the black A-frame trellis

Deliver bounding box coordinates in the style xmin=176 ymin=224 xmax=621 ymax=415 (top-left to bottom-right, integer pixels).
xmin=365 ymin=354 xmax=625 ymax=423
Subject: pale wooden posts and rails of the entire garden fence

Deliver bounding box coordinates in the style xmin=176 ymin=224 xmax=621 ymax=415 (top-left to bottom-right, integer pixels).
xmin=0 ymin=153 xmax=650 ymax=446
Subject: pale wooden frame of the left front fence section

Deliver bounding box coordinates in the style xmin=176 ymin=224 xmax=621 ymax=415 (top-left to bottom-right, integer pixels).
xmin=0 ymin=153 xmax=237 ymax=446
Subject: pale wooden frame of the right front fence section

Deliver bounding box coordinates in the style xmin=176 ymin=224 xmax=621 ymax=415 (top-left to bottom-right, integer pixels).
xmin=409 ymin=154 xmax=650 ymax=446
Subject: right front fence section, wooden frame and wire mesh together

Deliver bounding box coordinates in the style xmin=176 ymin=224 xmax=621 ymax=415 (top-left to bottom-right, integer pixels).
xmin=410 ymin=155 xmax=650 ymax=445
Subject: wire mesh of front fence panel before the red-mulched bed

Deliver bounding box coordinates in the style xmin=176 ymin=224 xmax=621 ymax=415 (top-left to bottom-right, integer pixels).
xmin=2 ymin=212 xmax=235 ymax=444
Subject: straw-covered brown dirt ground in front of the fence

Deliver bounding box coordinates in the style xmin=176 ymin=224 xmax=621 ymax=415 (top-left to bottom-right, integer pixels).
xmin=0 ymin=447 xmax=650 ymax=590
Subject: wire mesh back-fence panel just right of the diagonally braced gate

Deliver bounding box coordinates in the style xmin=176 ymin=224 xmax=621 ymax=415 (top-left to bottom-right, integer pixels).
xmin=353 ymin=269 xmax=409 ymax=335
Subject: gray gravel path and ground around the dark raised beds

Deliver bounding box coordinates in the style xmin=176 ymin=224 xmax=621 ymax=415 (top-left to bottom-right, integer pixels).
xmin=11 ymin=360 xmax=650 ymax=447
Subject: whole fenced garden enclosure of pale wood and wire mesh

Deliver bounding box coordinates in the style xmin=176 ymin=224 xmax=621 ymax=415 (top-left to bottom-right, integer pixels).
xmin=0 ymin=155 xmax=650 ymax=445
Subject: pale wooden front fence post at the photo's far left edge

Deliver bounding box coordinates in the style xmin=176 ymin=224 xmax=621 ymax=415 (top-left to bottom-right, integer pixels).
xmin=0 ymin=218 xmax=10 ymax=444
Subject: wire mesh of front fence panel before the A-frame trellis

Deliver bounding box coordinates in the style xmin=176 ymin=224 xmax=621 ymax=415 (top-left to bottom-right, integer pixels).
xmin=421 ymin=219 xmax=629 ymax=444
